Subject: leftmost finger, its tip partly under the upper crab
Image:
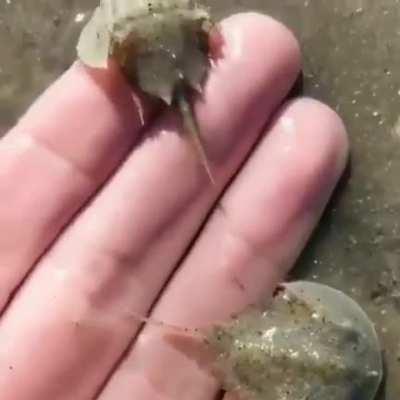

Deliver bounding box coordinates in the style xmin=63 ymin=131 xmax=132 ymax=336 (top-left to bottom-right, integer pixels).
xmin=0 ymin=64 xmax=152 ymax=310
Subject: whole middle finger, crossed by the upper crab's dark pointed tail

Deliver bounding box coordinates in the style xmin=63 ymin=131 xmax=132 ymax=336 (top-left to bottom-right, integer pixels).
xmin=0 ymin=14 xmax=299 ymax=400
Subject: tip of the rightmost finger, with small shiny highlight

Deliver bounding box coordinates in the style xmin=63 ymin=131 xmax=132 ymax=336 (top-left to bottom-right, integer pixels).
xmin=219 ymin=98 xmax=348 ymax=253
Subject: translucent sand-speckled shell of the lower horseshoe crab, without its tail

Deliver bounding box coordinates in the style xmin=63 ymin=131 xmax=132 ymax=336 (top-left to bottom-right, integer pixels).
xmin=207 ymin=281 xmax=383 ymax=400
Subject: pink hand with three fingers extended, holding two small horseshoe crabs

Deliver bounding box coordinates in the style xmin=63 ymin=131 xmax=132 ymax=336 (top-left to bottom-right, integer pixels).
xmin=0 ymin=13 xmax=348 ymax=400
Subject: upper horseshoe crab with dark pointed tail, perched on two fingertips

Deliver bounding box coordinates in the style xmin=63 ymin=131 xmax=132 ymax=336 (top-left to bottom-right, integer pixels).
xmin=77 ymin=0 xmax=214 ymax=182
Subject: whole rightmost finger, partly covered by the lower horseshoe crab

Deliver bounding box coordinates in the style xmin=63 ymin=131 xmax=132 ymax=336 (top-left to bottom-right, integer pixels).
xmin=100 ymin=99 xmax=347 ymax=400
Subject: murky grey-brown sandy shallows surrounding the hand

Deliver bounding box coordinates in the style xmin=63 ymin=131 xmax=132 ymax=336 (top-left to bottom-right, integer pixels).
xmin=0 ymin=0 xmax=400 ymax=400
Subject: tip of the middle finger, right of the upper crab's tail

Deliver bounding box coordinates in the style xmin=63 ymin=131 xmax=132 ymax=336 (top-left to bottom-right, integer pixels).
xmin=196 ymin=12 xmax=301 ymax=165
